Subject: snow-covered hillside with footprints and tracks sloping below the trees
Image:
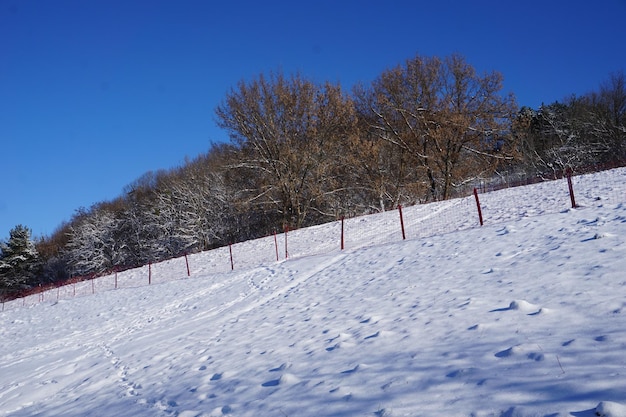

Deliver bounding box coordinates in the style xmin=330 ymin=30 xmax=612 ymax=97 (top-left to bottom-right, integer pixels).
xmin=0 ymin=169 xmax=626 ymax=417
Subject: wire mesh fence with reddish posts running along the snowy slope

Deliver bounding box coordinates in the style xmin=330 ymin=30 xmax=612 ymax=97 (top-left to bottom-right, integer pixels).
xmin=1 ymin=168 xmax=626 ymax=311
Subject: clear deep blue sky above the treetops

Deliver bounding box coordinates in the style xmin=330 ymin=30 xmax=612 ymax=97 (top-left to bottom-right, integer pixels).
xmin=0 ymin=0 xmax=626 ymax=239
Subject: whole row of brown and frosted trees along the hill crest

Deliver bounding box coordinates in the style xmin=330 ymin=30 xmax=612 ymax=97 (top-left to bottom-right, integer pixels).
xmin=0 ymin=55 xmax=626 ymax=297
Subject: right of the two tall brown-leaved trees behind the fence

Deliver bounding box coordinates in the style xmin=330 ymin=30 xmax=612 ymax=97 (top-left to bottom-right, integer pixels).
xmin=355 ymin=55 xmax=516 ymax=199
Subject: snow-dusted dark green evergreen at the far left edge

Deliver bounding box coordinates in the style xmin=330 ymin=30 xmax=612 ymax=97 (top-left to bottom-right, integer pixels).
xmin=0 ymin=225 xmax=41 ymax=298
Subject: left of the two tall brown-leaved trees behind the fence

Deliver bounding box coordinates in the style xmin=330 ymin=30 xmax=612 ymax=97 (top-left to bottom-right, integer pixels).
xmin=216 ymin=73 xmax=356 ymax=227
